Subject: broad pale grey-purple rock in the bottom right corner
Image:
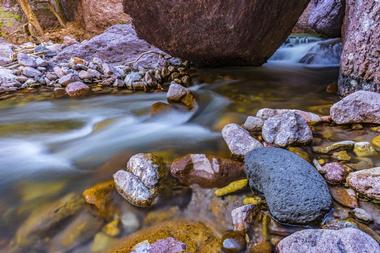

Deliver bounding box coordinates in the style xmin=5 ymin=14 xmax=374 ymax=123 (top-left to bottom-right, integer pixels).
xmin=277 ymin=228 xmax=380 ymax=253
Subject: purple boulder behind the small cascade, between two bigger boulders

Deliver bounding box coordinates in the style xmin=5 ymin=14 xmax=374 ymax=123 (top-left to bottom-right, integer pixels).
xmin=294 ymin=0 xmax=344 ymax=38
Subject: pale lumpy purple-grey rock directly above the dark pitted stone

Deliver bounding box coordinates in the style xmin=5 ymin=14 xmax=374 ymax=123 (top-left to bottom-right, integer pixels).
xmin=262 ymin=112 xmax=313 ymax=147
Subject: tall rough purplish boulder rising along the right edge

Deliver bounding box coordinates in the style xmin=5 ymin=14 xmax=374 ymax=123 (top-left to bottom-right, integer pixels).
xmin=338 ymin=0 xmax=380 ymax=96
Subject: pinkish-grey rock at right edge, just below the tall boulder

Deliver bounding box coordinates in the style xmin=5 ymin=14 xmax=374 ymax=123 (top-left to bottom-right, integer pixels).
xmin=330 ymin=91 xmax=380 ymax=124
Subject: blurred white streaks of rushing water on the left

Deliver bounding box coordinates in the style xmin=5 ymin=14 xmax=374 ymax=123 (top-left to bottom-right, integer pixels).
xmin=0 ymin=91 xmax=228 ymax=184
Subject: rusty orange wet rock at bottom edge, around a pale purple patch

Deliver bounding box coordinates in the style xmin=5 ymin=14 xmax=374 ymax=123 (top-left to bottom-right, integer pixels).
xmin=109 ymin=220 xmax=221 ymax=253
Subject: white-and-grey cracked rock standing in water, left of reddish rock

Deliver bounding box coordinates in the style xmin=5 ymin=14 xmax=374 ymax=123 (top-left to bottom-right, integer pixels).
xmin=113 ymin=153 xmax=166 ymax=207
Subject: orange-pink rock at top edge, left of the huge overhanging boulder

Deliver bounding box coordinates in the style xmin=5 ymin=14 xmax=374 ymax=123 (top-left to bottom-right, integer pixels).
xmin=81 ymin=0 xmax=131 ymax=33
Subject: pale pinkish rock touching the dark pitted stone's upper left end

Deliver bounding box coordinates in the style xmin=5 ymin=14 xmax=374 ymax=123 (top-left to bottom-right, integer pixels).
xmin=222 ymin=123 xmax=262 ymax=157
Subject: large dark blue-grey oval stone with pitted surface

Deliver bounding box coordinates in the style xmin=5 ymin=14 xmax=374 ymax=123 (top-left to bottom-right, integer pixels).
xmin=245 ymin=148 xmax=332 ymax=224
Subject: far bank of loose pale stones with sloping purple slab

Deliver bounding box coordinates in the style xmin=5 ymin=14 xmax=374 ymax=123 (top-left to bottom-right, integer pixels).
xmin=0 ymin=25 xmax=191 ymax=97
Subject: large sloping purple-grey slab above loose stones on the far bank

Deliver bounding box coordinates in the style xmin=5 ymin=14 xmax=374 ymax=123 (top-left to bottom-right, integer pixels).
xmin=52 ymin=24 xmax=175 ymax=69
